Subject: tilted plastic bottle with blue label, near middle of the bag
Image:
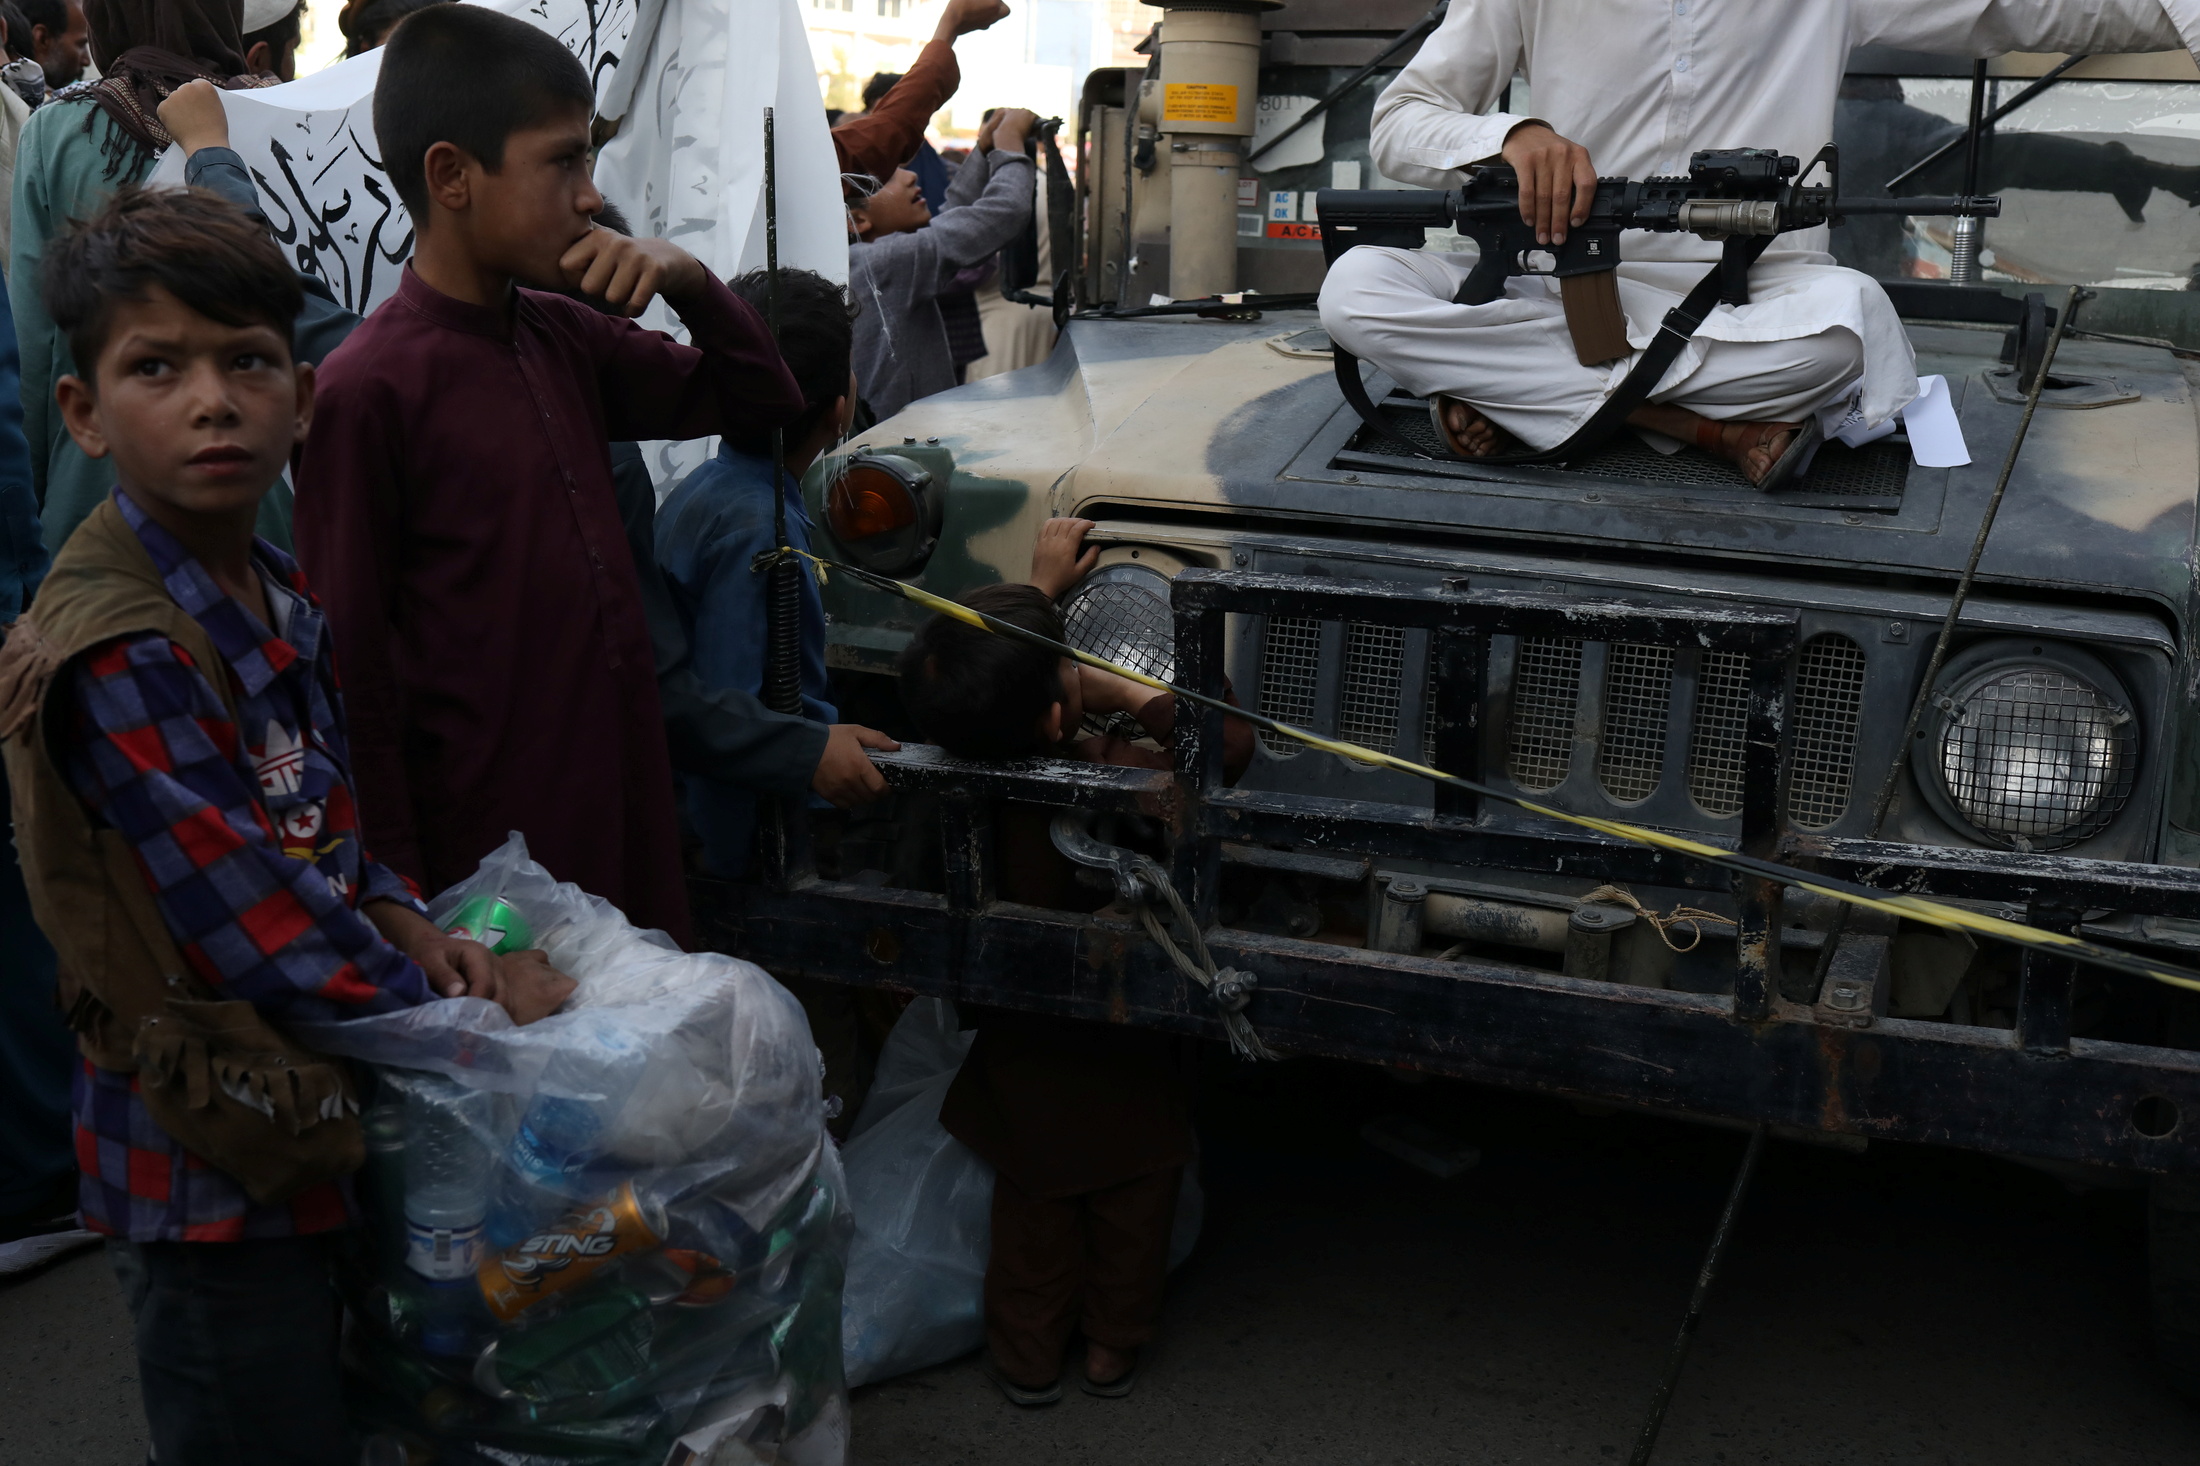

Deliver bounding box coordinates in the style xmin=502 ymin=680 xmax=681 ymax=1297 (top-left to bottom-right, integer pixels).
xmin=488 ymin=1026 xmax=645 ymax=1250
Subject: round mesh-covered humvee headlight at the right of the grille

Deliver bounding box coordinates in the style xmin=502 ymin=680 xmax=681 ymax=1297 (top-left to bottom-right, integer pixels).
xmin=1918 ymin=643 xmax=2138 ymax=850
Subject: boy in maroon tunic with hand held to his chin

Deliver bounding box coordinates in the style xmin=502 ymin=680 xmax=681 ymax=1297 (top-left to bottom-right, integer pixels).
xmin=295 ymin=4 xmax=803 ymax=942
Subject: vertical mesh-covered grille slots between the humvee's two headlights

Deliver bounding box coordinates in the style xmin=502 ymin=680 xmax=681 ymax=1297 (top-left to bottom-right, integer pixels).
xmin=1261 ymin=616 xmax=1863 ymax=830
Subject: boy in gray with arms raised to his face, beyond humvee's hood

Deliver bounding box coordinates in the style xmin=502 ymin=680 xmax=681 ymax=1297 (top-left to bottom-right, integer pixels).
xmin=847 ymin=108 xmax=1038 ymax=418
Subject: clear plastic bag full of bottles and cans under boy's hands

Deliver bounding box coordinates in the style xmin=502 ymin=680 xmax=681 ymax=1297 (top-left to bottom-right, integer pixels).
xmin=299 ymin=834 xmax=851 ymax=1466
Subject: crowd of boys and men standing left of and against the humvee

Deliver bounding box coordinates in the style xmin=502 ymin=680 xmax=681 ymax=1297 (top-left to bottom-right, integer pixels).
xmin=0 ymin=0 xmax=1188 ymax=1464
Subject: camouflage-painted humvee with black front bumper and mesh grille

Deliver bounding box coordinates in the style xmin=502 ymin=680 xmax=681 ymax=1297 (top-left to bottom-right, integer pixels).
xmin=711 ymin=0 xmax=2200 ymax=1389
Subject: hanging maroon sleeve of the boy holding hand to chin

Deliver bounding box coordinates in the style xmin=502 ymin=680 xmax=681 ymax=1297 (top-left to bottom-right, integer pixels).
xmin=295 ymin=376 xmax=427 ymax=883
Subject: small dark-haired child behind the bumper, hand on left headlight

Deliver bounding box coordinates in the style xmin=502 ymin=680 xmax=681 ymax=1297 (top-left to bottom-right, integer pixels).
xmin=900 ymin=519 xmax=1252 ymax=1407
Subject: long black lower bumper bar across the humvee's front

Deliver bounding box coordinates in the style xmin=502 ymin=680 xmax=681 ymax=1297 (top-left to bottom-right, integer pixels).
xmin=697 ymin=880 xmax=2200 ymax=1171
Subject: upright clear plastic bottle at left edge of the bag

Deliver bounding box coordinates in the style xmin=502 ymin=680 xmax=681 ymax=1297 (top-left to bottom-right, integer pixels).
xmin=405 ymin=1074 xmax=495 ymax=1354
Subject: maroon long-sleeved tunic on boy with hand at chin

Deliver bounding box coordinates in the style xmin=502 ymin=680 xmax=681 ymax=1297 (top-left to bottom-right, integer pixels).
xmin=295 ymin=269 xmax=801 ymax=942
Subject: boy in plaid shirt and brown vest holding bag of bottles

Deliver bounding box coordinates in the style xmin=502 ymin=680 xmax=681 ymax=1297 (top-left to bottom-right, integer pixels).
xmin=0 ymin=189 xmax=572 ymax=1466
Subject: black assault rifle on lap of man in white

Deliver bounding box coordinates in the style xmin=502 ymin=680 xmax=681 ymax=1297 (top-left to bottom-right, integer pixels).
xmin=1313 ymin=143 xmax=2002 ymax=365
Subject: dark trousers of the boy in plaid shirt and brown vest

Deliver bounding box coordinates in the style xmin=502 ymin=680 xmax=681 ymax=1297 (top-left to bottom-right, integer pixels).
xmin=108 ymin=1233 xmax=359 ymax=1466
